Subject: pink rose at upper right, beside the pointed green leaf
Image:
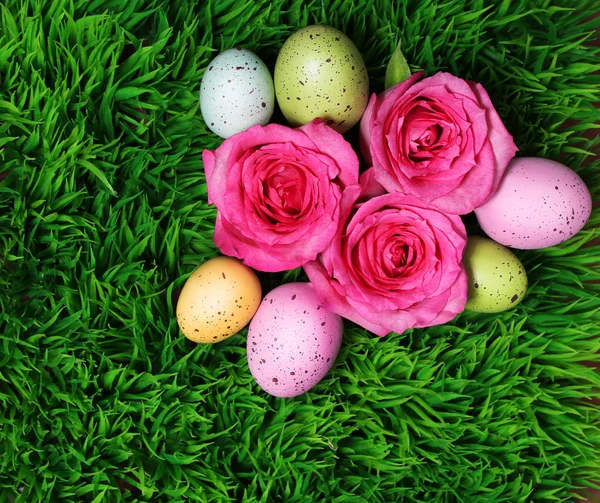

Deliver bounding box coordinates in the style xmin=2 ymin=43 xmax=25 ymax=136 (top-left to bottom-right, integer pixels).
xmin=360 ymin=72 xmax=518 ymax=215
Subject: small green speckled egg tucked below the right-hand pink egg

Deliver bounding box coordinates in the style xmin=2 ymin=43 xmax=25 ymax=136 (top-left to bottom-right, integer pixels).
xmin=463 ymin=236 xmax=527 ymax=313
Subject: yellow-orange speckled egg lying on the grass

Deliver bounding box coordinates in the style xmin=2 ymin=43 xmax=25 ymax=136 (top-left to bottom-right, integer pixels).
xmin=177 ymin=257 xmax=262 ymax=344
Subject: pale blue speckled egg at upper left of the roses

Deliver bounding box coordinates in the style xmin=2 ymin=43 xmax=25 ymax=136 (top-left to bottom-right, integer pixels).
xmin=200 ymin=48 xmax=275 ymax=138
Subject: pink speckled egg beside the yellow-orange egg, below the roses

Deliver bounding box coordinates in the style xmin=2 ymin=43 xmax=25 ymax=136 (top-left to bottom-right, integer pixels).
xmin=246 ymin=283 xmax=343 ymax=398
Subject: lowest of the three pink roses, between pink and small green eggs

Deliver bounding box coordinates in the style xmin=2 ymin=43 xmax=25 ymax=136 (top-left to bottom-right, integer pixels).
xmin=304 ymin=170 xmax=467 ymax=336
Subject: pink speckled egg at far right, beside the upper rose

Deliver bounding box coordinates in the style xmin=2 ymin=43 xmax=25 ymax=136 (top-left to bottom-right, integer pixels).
xmin=475 ymin=157 xmax=592 ymax=250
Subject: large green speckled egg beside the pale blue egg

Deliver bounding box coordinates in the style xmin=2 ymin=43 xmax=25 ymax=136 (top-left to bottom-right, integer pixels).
xmin=274 ymin=25 xmax=369 ymax=133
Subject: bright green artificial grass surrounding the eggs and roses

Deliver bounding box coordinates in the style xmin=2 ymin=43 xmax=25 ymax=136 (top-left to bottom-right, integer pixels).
xmin=0 ymin=0 xmax=600 ymax=503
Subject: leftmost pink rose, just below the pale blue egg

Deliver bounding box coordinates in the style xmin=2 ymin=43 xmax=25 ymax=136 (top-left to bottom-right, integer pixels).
xmin=202 ymin=120 xmax=358 ymax=272
